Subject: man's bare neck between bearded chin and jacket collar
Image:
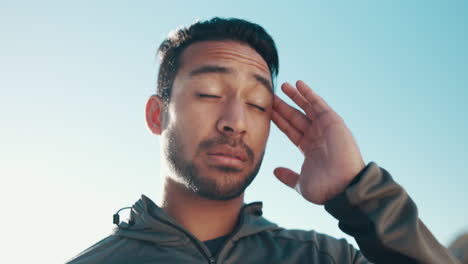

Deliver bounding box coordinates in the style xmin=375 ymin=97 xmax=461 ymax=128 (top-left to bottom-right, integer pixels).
xmin=162 ymin=178 xmax=244 ymax=241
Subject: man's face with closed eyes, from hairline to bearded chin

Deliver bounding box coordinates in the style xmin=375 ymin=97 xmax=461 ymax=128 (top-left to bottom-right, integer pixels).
xmin=162 ymin=41 xmax=273 ymax=200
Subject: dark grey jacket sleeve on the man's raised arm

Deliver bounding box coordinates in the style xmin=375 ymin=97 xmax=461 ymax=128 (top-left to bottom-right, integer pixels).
xmin=325 ymin=162 xmax=459 ymax=264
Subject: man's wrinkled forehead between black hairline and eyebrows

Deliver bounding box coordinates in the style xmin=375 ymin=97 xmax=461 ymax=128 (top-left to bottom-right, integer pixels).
xmin=180 ymin=40 xmax=271 ymax=79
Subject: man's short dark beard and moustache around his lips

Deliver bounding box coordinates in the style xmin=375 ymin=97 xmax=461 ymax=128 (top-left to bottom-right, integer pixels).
xmin=164 ymin=127 xmax=265 ymax=201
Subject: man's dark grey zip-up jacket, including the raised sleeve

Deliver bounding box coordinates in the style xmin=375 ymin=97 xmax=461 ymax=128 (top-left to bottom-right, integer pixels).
xmin=69 ymin=163 xmax=459 ymax=264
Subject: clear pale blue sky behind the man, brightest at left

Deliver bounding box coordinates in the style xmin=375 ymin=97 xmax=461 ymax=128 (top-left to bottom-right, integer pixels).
xmin=0 ymin=0 xmax=468 ymax=263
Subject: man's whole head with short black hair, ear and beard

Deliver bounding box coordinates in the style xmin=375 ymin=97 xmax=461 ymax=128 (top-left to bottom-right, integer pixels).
xmin=147 ymin=18 xmax=278 ymax=200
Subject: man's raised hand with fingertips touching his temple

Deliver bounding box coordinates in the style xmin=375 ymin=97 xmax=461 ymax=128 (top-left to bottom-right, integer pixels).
xmin=272 ymin=81 xmax=365 ymax=204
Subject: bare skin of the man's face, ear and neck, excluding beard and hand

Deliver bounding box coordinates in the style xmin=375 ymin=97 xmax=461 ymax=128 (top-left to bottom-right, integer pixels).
xmin=147 ymin=41 xmax=274 ymax=241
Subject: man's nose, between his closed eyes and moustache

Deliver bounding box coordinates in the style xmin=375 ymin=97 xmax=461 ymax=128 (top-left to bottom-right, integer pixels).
xmin=216 ymin=100 xmax=247 ymax=137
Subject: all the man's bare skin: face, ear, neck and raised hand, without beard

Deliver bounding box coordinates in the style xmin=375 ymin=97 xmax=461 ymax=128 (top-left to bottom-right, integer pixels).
xmin=146 ymin=41 xmax=365 ymax=241
